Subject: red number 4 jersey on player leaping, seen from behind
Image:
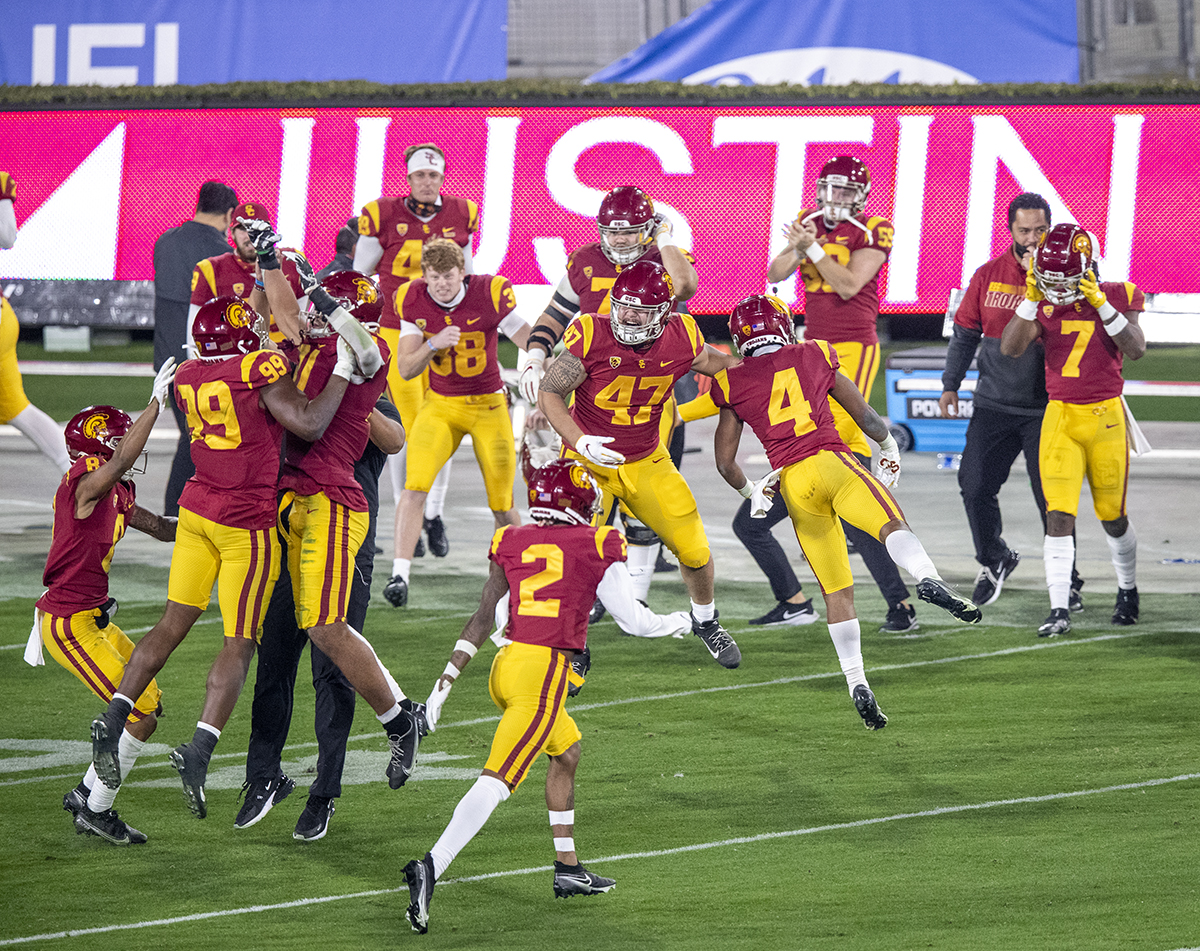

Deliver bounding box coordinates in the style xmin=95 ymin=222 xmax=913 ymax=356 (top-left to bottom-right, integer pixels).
xmin=709 ymin=340 xmax=850 ymax=468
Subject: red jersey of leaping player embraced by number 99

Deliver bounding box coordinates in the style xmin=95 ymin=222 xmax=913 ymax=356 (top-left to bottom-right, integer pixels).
xmin=280 ymin=336 xmax=391 ymax=512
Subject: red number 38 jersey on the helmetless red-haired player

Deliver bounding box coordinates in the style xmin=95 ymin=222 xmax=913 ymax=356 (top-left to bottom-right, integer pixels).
xmin=396 ymin=274 xmax=517 ymax=396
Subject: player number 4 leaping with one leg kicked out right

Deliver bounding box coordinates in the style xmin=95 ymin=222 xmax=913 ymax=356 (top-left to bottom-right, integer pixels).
xmin=712 ymin=294 xmax=982 ymax=730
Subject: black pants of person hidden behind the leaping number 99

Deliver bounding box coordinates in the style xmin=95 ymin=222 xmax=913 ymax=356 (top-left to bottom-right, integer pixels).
xmin=246 ymin=530 xmax=374 ymax=799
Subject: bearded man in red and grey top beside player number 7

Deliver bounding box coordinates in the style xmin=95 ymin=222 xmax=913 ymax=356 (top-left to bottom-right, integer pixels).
xmin=938 ymin=192 xmax=1084 ymax=611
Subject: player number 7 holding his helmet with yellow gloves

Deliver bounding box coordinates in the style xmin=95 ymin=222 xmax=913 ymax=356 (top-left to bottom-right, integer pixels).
xmin=1000 ymin=223 xmax=1146 ymax=638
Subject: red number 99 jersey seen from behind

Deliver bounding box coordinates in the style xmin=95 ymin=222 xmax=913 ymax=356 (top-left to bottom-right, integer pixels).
xmin=175 ymin=351 xmax=292 ymax=528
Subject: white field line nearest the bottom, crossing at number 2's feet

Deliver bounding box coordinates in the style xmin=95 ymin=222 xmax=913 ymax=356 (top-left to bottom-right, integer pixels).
xmin=0 ymin=773 xmax=1200 ymax=951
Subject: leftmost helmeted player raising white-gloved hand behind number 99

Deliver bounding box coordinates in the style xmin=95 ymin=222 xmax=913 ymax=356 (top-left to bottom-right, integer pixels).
xmin=25 ymin=365 xmax=175 ymax=845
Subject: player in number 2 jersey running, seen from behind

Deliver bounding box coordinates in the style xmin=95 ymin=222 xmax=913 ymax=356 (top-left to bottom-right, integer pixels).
xmin=404 ymin=459 xmax=625 ymax=934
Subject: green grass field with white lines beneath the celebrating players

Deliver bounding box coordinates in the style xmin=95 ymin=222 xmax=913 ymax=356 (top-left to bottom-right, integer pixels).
xmin=0 ymin=566 xmax=1200 ymax=951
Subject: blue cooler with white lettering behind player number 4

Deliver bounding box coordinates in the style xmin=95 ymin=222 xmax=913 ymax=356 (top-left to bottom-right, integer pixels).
xmin=883 ymin=346 xmax=979 ymax=453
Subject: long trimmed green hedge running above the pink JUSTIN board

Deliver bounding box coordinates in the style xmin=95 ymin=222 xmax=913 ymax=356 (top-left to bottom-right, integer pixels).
xmin=7 ymin=79 xmax=1200 ymax=112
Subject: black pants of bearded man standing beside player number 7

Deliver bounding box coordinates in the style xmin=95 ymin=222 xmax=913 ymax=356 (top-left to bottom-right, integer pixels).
xmin=959 ymin=406 xmax=1046 ymax=564
